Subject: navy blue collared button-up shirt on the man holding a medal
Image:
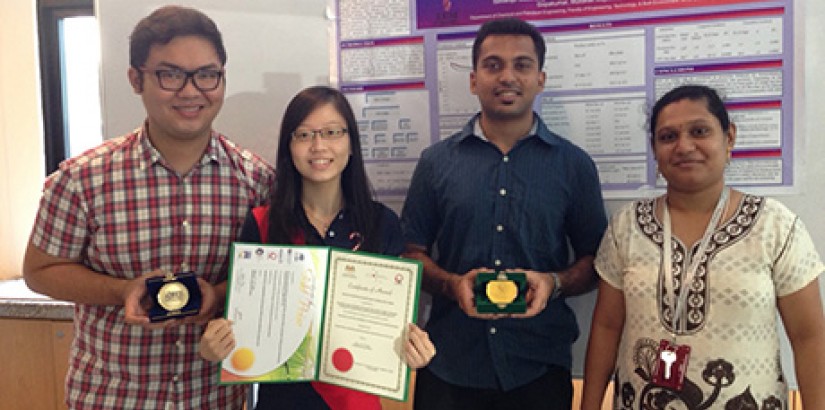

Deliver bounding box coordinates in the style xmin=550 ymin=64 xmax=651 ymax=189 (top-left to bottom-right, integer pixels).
xmin=401 ymin=115 xmax=607 ymax=390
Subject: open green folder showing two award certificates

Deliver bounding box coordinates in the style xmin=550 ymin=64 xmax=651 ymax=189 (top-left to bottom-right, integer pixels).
xmin=220 ymin=243 xmax=421 ymax=400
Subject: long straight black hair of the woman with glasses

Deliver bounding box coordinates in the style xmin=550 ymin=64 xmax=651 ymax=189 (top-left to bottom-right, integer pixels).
xmin=267 ymin=86 xmax=381 ymax=252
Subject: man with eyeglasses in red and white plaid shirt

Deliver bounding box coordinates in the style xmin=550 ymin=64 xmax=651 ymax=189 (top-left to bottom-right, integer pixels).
xmin=23 ymin=6 xmax=274 ymax=409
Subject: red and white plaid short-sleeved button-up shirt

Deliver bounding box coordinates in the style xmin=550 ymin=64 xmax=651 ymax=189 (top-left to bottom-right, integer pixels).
xmin=32 ymin=129 xmax=274 ymax=409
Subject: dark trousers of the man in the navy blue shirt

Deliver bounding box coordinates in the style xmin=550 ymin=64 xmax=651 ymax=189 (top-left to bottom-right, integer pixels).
xmin=413 ymin=366 xmax=573 ymax=410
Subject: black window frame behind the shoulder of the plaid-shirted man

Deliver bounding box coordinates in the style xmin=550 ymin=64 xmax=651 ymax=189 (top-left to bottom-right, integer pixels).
xmin=37 ymin=0 xmax=95 ymax=175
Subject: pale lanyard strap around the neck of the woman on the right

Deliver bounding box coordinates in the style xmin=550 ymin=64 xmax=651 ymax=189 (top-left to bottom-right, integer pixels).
xmin=662 ymin=187 xmax=730 ymax=334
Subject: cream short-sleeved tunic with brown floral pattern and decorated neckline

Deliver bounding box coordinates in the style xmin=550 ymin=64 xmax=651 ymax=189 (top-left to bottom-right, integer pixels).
xmin=595 ymin=195 xmax=823 ymax=409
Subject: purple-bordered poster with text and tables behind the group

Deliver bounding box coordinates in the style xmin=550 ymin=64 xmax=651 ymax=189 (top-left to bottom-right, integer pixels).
xmin=334 ymin=0 xmax=794 ymax=199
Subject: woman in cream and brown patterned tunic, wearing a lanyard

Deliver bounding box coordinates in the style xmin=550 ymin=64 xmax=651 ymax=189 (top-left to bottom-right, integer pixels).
xmin=582 ymin=85 xmax=825 ymax=410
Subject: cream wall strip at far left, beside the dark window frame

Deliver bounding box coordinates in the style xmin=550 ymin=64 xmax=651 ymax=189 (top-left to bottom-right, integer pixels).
xmin=0 ymin=0 xmax=45 ymax=279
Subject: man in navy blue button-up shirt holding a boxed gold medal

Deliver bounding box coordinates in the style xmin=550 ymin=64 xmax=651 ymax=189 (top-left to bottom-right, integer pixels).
xmin=402 ymin=19 xmax=607 ymax=410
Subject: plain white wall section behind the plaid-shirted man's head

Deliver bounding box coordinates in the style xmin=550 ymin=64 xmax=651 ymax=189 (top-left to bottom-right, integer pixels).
xmin=100 ymin=0 xmax=332 ymax=161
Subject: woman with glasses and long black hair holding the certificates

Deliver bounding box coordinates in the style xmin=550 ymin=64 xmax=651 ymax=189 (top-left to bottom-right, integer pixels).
xmin=201 ymin=87 xmax=435 ymax=410
